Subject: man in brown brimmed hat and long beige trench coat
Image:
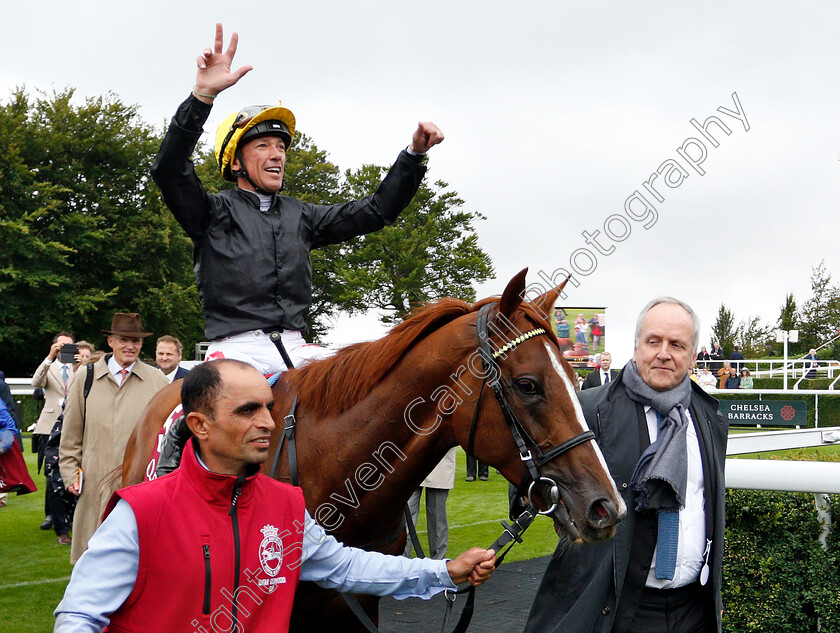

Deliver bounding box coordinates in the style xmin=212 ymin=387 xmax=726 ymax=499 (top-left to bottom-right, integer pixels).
xmin=58 ymin=312 xmax=169 ymax=563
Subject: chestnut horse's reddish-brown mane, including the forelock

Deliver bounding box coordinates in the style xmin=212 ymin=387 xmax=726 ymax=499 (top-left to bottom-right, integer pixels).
xmin=283 ymin=297 xmax=559 ymax=418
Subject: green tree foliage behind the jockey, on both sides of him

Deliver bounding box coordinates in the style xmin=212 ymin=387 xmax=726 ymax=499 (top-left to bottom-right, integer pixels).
xmin=0 ymin=88 xmax=492 ymax=376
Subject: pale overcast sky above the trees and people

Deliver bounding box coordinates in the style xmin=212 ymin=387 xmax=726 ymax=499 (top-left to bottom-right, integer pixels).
xmin=0 ymin=0 xmax=840 ymax=364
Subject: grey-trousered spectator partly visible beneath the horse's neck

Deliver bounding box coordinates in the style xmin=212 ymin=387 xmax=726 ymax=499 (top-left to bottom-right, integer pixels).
xmin=403 ymin=448 xmax=456 ymax=560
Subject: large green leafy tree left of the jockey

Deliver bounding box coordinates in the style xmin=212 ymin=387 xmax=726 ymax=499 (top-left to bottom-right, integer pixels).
xmin=0 ymin=89 xmax=200 ymax=375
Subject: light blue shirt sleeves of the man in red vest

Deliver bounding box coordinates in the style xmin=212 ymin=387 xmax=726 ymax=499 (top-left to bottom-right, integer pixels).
xmin=53 ymin=478 xmax=455 ymax=633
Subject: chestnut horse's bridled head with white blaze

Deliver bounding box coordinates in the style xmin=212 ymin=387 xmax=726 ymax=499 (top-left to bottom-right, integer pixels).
xmin=453 ymin=269 xmax=626 ymax=542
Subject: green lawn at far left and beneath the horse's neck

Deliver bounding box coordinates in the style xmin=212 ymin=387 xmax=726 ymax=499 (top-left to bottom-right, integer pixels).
xmin=0 ymin=440 xmax=557 ymax=633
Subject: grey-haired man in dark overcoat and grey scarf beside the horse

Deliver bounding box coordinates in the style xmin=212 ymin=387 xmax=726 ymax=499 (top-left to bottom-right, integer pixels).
xmin=525 ymin=297 xmax=728 ymax=633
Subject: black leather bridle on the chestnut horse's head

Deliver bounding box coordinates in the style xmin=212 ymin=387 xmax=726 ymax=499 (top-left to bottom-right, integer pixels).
xmin=467 ymin=302 xmax=595 ymax=514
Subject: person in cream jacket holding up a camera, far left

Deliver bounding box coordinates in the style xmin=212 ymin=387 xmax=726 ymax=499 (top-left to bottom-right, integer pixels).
xmin=32 ymin=332 xmax=77 ymax=545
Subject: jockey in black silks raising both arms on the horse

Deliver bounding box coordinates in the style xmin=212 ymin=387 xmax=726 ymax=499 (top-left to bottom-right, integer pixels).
xmin=151 ymin=24 xmax=443 ymax=374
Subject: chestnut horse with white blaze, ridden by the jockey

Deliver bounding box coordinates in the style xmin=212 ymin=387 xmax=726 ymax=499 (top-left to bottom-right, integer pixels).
xmin=123 ymin=269 xmax=625 ymax=633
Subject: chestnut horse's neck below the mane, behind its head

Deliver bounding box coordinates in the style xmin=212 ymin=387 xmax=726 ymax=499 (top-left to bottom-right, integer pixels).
xmin=300 ymin=336 xmax=466 ymax=544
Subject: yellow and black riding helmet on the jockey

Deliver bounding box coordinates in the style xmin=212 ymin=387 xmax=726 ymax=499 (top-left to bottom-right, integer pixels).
xmin=216 ymin=105 xmax=295 ymax=182
